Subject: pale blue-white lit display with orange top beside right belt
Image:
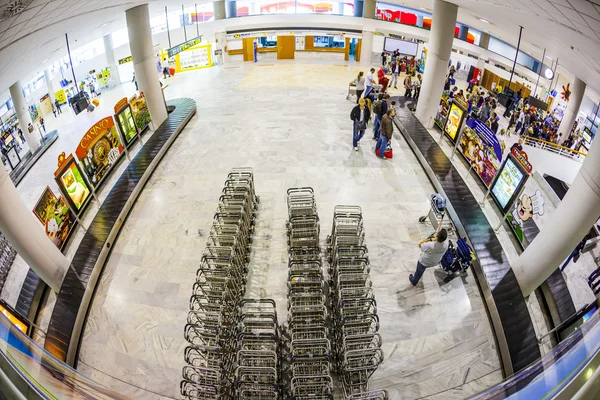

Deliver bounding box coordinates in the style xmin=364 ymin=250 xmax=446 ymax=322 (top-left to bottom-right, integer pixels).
xmin=490 ymin=148 xmax=531 ymax=212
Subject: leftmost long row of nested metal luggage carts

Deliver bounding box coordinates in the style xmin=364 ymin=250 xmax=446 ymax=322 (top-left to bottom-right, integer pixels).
xmin=180 ymin=168 xmax=270 ymax=400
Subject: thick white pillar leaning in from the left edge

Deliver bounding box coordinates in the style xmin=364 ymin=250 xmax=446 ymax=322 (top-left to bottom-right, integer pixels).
xmin=0 ymin=168 xmax=69 ymax=292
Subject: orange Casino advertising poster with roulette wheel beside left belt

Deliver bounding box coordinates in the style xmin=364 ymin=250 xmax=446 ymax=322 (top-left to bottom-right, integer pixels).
xmin=75 ymin=117 xmax=123 ymax=186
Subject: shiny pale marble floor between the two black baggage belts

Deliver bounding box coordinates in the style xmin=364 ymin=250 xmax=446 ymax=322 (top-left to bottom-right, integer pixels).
xmin=78 ymin=61 xmax=502 ymax=399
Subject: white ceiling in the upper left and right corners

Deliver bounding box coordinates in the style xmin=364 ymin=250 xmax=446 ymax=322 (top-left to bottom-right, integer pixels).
xmin=0 ymin=0 xmax=600 ymax=96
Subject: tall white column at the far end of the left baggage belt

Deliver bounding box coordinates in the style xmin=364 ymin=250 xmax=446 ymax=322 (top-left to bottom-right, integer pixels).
xmin=125 ymin=4 xmax=168 ymax=129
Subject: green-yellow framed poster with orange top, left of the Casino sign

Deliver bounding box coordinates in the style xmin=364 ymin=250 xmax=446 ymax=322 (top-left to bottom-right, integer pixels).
xmin=54 ymin=153 xmax=91 ymax=212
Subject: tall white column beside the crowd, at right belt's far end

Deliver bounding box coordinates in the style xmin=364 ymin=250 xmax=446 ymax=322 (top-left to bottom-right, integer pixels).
xmin=415 ymin=0 xmax=458 ymax=128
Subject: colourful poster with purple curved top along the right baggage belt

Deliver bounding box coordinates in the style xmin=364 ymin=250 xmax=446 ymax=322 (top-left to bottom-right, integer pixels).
xmin=458 ymin=119 xmax=502 ymax=187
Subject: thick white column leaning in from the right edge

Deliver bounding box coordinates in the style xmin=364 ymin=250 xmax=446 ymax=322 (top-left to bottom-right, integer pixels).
xmin=512 ymin=131 xmax=600 ymax=297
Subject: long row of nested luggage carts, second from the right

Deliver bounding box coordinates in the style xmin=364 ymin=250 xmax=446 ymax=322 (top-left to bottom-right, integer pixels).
xmin=285 ymin=188 xmax=333 ymax=400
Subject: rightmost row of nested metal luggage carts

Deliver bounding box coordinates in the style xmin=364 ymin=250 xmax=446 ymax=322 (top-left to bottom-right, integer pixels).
xmin=327 ymin=206 xmax=388 ymax=400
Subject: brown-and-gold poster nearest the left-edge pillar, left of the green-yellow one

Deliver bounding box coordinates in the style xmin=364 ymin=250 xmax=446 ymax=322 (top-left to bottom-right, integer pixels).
xmin=33 ymin=187 xmax=75 ymax=250
